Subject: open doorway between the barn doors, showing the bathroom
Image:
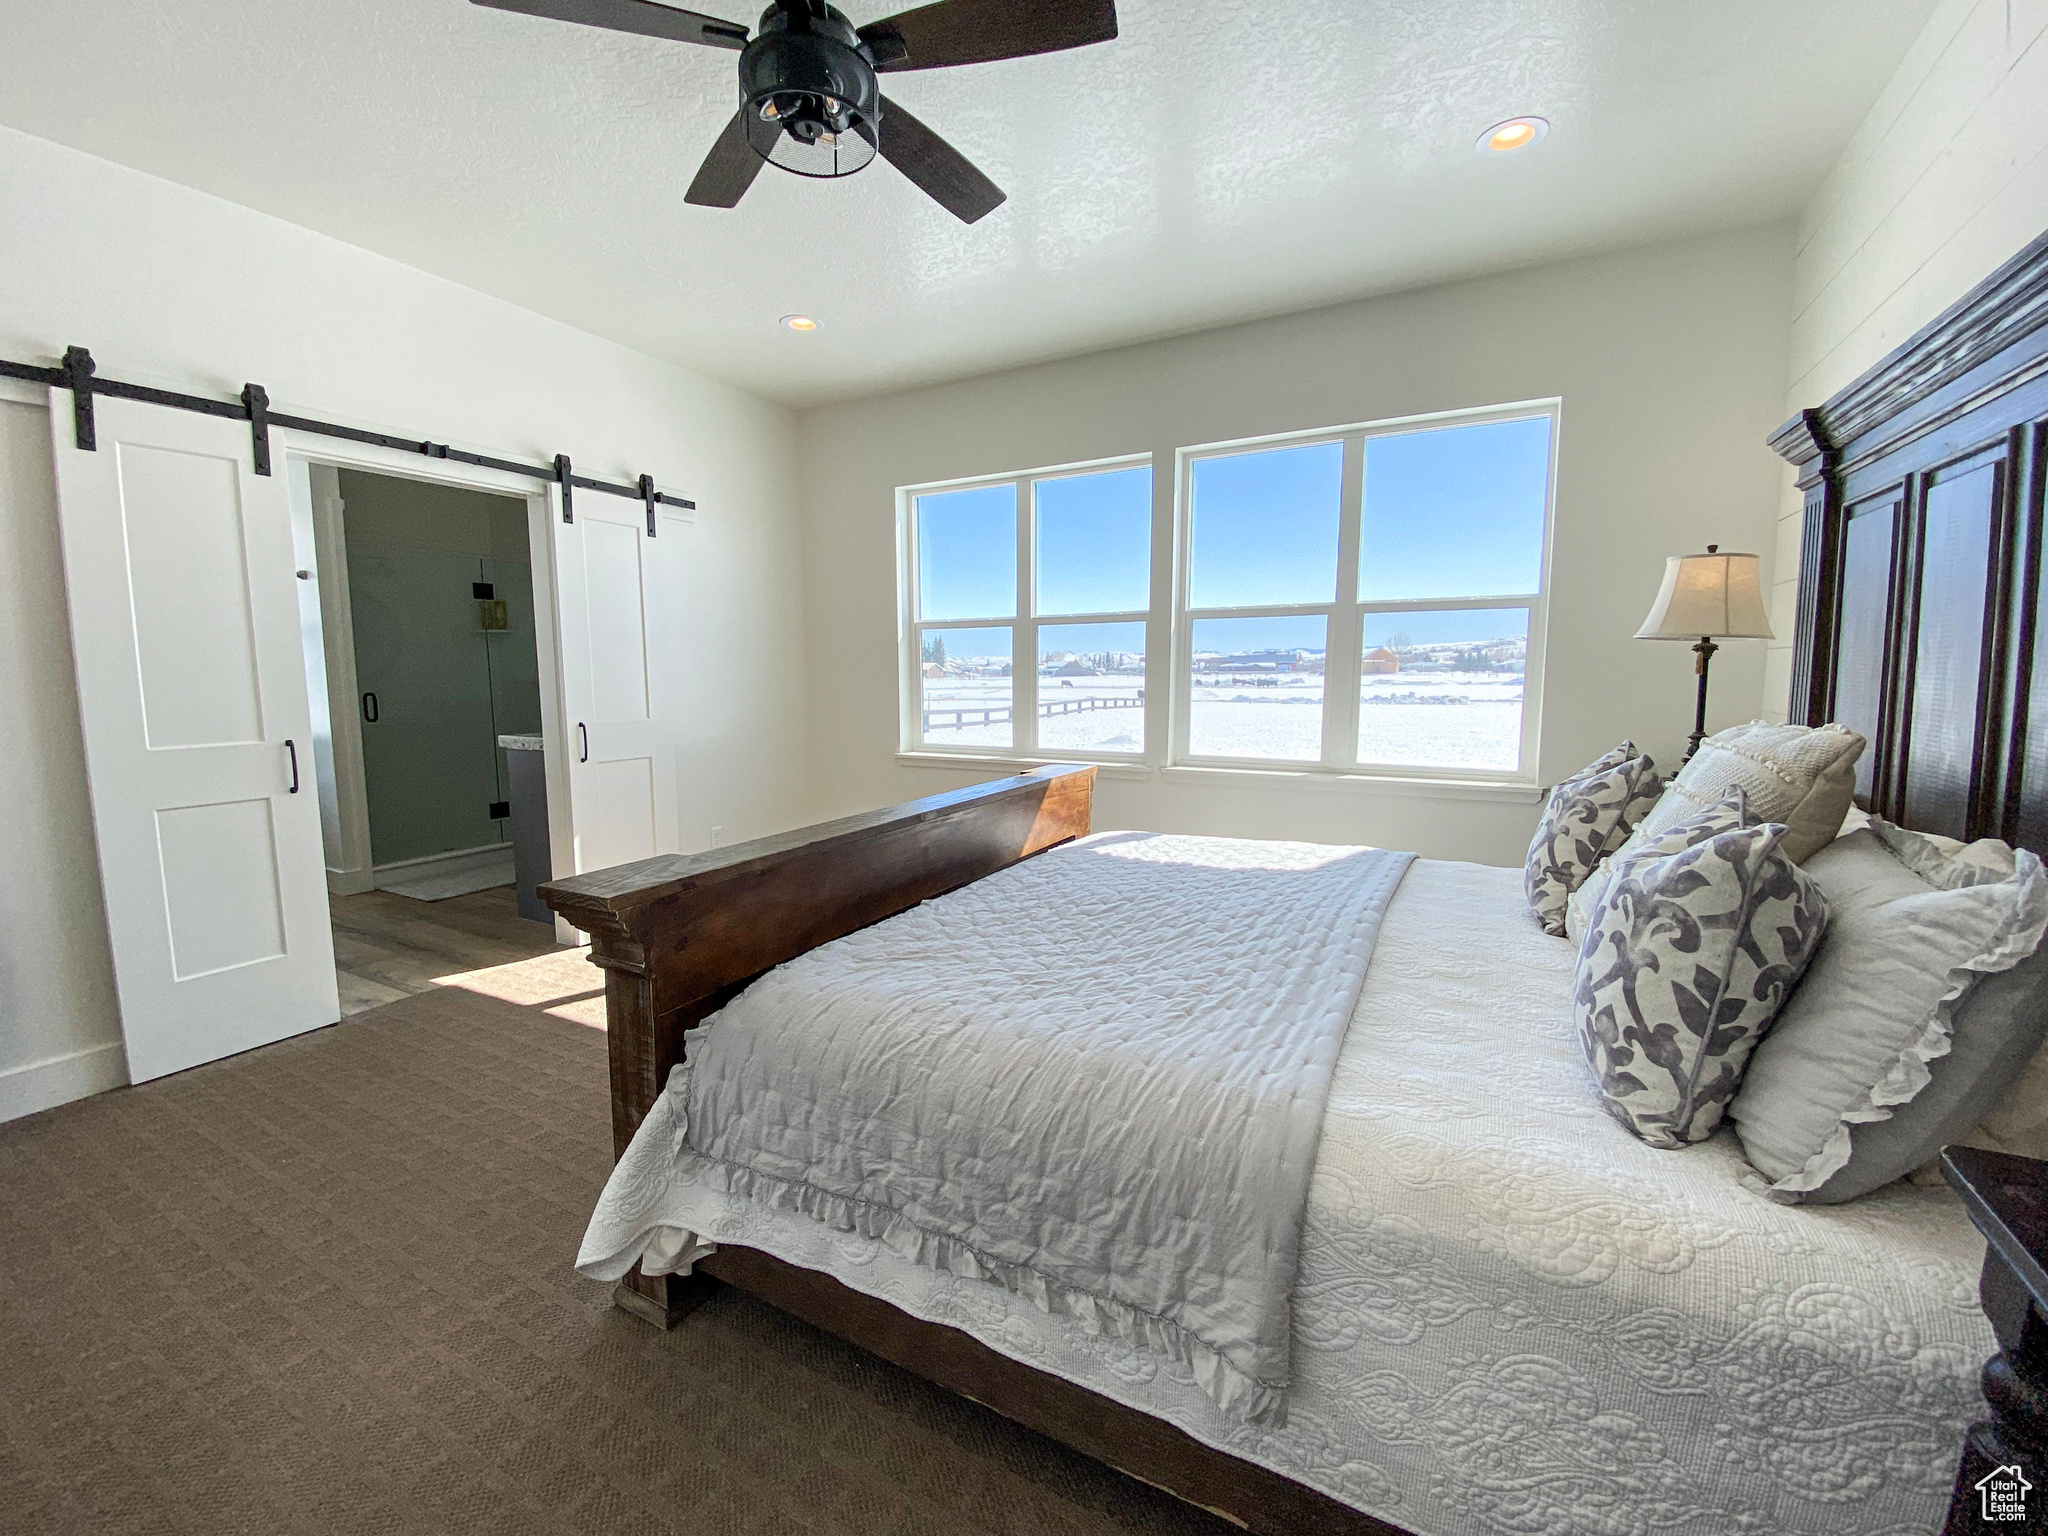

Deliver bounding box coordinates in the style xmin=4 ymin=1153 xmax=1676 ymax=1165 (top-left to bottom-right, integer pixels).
xmin=293 ymin=461 xmax=557 ymax=1016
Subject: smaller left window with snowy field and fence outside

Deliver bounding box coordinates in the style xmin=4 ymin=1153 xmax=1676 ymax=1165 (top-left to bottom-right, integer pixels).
xmin=905 ymin=463 xmax=1153 ymax=760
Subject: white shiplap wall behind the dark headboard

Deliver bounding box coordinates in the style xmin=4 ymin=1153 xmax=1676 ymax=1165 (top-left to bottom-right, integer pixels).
xmin=1765 ymin=0 xmax=2048 ymax=719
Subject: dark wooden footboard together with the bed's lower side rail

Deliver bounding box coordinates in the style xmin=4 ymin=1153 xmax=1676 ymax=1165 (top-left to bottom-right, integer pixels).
xmin=541 ymin=766 xmax=1405 ymax=1536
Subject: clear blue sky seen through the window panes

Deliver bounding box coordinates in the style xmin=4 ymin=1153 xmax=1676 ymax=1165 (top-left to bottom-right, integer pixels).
xmin=918 ymin=416 xmax=1550 ymax=655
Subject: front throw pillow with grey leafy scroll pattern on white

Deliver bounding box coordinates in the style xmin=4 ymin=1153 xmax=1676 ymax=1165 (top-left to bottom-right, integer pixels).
xmin=1573 ymin=811 xmax=1827 ymax=1147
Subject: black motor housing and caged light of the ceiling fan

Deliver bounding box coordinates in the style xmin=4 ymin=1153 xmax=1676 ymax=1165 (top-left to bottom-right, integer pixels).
xmin=739 ymin=0 xmax=883 ymax=176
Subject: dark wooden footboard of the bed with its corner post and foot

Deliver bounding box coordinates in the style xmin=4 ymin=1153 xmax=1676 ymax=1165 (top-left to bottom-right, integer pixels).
xmin=541 ymin=764 xmax=1096 ymax=1327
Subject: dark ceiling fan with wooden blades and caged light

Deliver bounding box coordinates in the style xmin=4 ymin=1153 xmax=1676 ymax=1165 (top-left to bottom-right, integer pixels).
xmin=473 ymin=0 xmax=1116 ymax=223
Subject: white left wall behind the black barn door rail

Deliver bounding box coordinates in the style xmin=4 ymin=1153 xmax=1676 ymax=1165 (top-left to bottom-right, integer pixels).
xmin=0 ymin=129 xmax=805 ymax=1118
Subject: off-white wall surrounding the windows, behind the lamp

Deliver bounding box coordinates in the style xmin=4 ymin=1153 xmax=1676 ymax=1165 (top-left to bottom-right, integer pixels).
xmin=799 ymin=225 xmax=1792 ymax=864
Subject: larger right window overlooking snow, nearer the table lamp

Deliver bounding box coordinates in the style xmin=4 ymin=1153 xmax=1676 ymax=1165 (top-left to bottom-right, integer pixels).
xmin=1176 ymin=408 xmax=1554 ymax=778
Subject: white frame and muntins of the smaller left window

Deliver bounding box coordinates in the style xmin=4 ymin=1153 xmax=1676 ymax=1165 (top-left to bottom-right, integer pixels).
xmin=897 ymin=453 xmax=1159 ymax=764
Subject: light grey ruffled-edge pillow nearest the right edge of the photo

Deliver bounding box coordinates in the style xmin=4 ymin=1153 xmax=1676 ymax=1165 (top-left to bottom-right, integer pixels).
xmin=1731 ymin=819 xmax=2048 ymax=1204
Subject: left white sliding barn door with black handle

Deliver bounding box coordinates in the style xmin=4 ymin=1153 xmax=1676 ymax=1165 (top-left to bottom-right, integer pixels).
xmin=51 ymin=391 xmax=340 ymax=1081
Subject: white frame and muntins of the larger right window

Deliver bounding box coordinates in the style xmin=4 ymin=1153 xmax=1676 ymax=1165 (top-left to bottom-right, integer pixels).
xmin=1179 ymin=399 xmax=1563 ymax=784
